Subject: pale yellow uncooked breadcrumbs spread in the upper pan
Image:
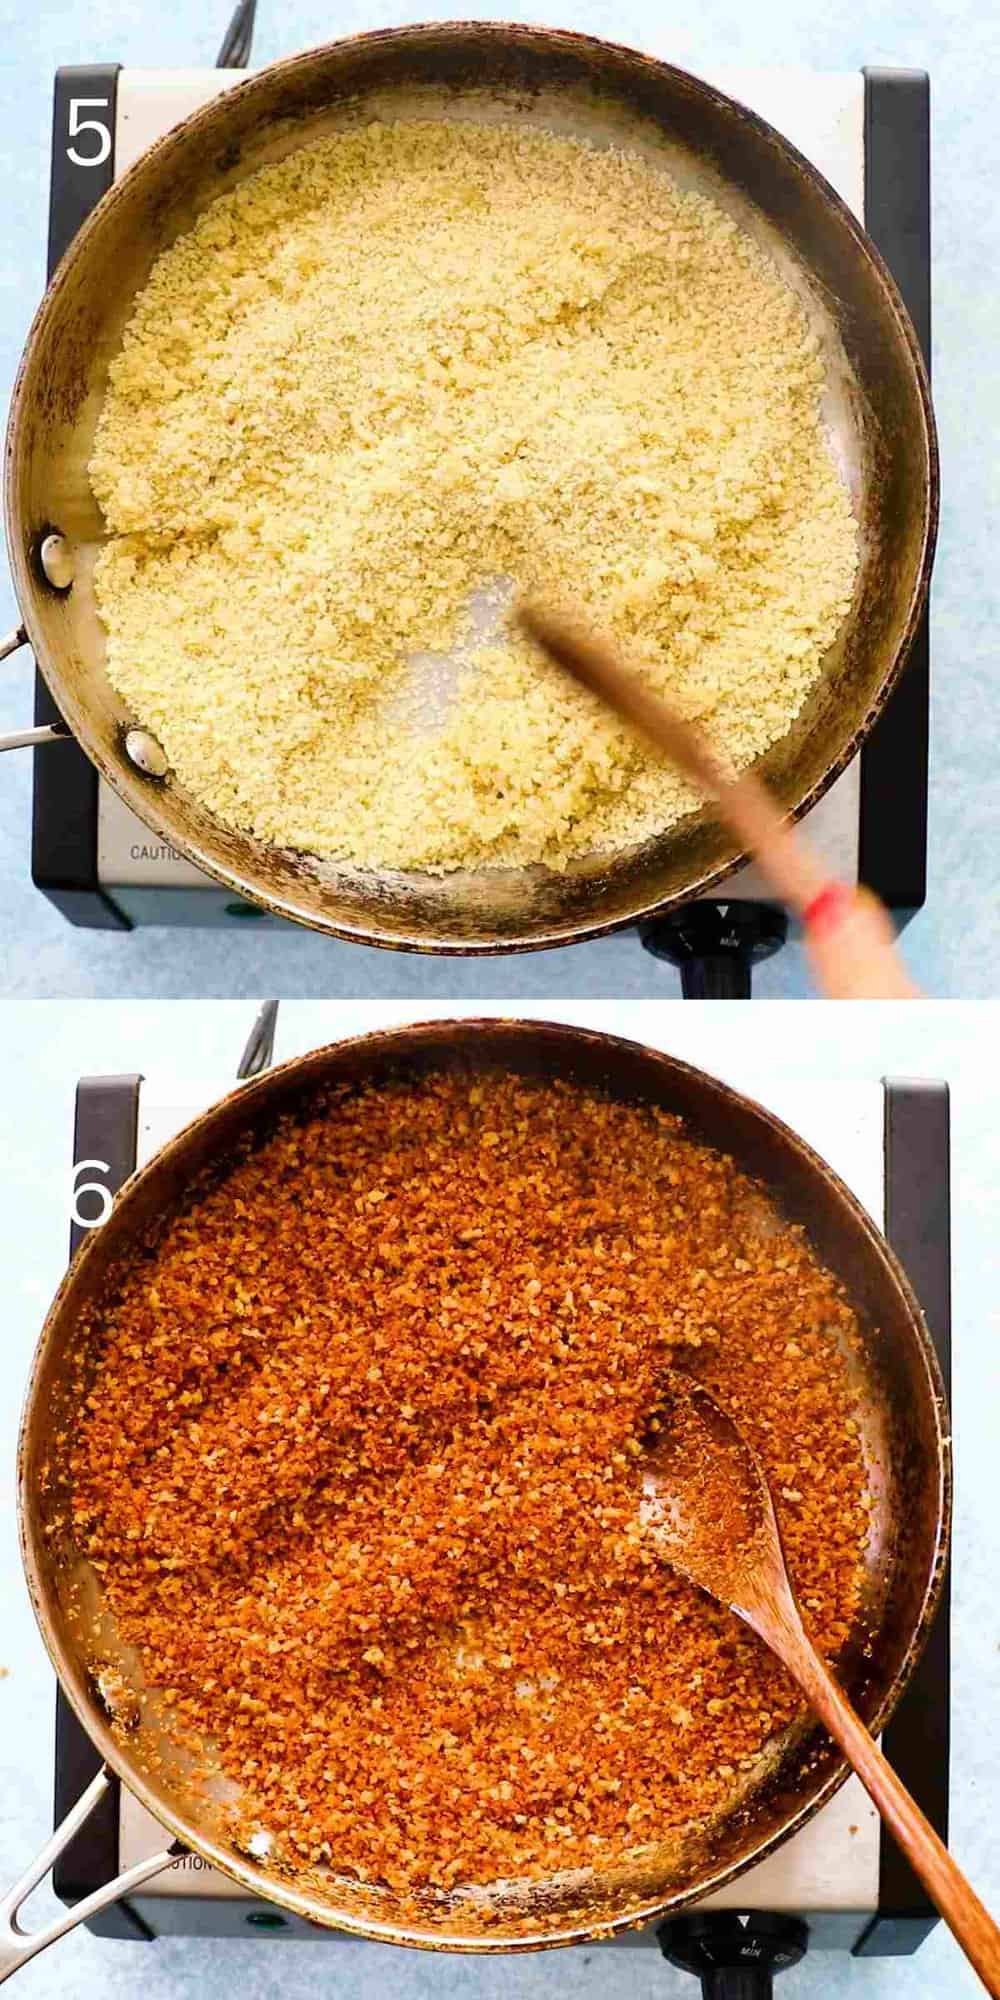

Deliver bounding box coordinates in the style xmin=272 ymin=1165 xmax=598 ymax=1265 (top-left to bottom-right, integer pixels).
xmin=90 ymin=122 xmax=858 ymax=870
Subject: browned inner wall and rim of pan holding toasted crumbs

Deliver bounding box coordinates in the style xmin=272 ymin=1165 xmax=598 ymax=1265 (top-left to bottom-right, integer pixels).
xmin=20 ymin=1020 xmax=950 ymax=1950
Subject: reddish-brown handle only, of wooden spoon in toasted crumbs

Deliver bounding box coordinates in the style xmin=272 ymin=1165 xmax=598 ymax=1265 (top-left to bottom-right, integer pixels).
xmin=782 ymin=1634 xmax=1000 ymax=2000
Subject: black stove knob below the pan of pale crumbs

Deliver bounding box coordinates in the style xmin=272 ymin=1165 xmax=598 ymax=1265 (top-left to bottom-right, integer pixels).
xmin=638 ymin=902 xmax=788 ymax=1000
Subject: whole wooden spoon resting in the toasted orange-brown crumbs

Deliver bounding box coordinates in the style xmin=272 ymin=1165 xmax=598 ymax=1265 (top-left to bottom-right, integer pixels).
xmin=640 ymin=1378 xmax=1000 ymax=2000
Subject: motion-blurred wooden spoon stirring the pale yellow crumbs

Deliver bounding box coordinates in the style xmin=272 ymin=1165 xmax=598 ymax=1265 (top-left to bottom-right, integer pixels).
xmin=516 ymin=598 xmax=918 ymax=1000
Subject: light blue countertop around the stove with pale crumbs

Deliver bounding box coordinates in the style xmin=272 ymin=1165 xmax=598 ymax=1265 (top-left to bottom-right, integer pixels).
xmin=0 ymin=0 xmax=1000 ymax=1000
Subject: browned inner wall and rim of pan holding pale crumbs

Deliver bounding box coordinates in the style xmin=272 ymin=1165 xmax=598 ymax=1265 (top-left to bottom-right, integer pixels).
xmin=6 ymin=22 xmax=936 ymax=952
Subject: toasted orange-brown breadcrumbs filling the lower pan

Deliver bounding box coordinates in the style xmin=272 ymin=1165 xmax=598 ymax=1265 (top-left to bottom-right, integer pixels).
xmin=68 ymin=1074 xmax=870 ymax=1890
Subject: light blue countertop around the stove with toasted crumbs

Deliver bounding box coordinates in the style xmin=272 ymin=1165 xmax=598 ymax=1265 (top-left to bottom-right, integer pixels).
xmin=0 ymin=1002 xmax=1000 ymax=2000
